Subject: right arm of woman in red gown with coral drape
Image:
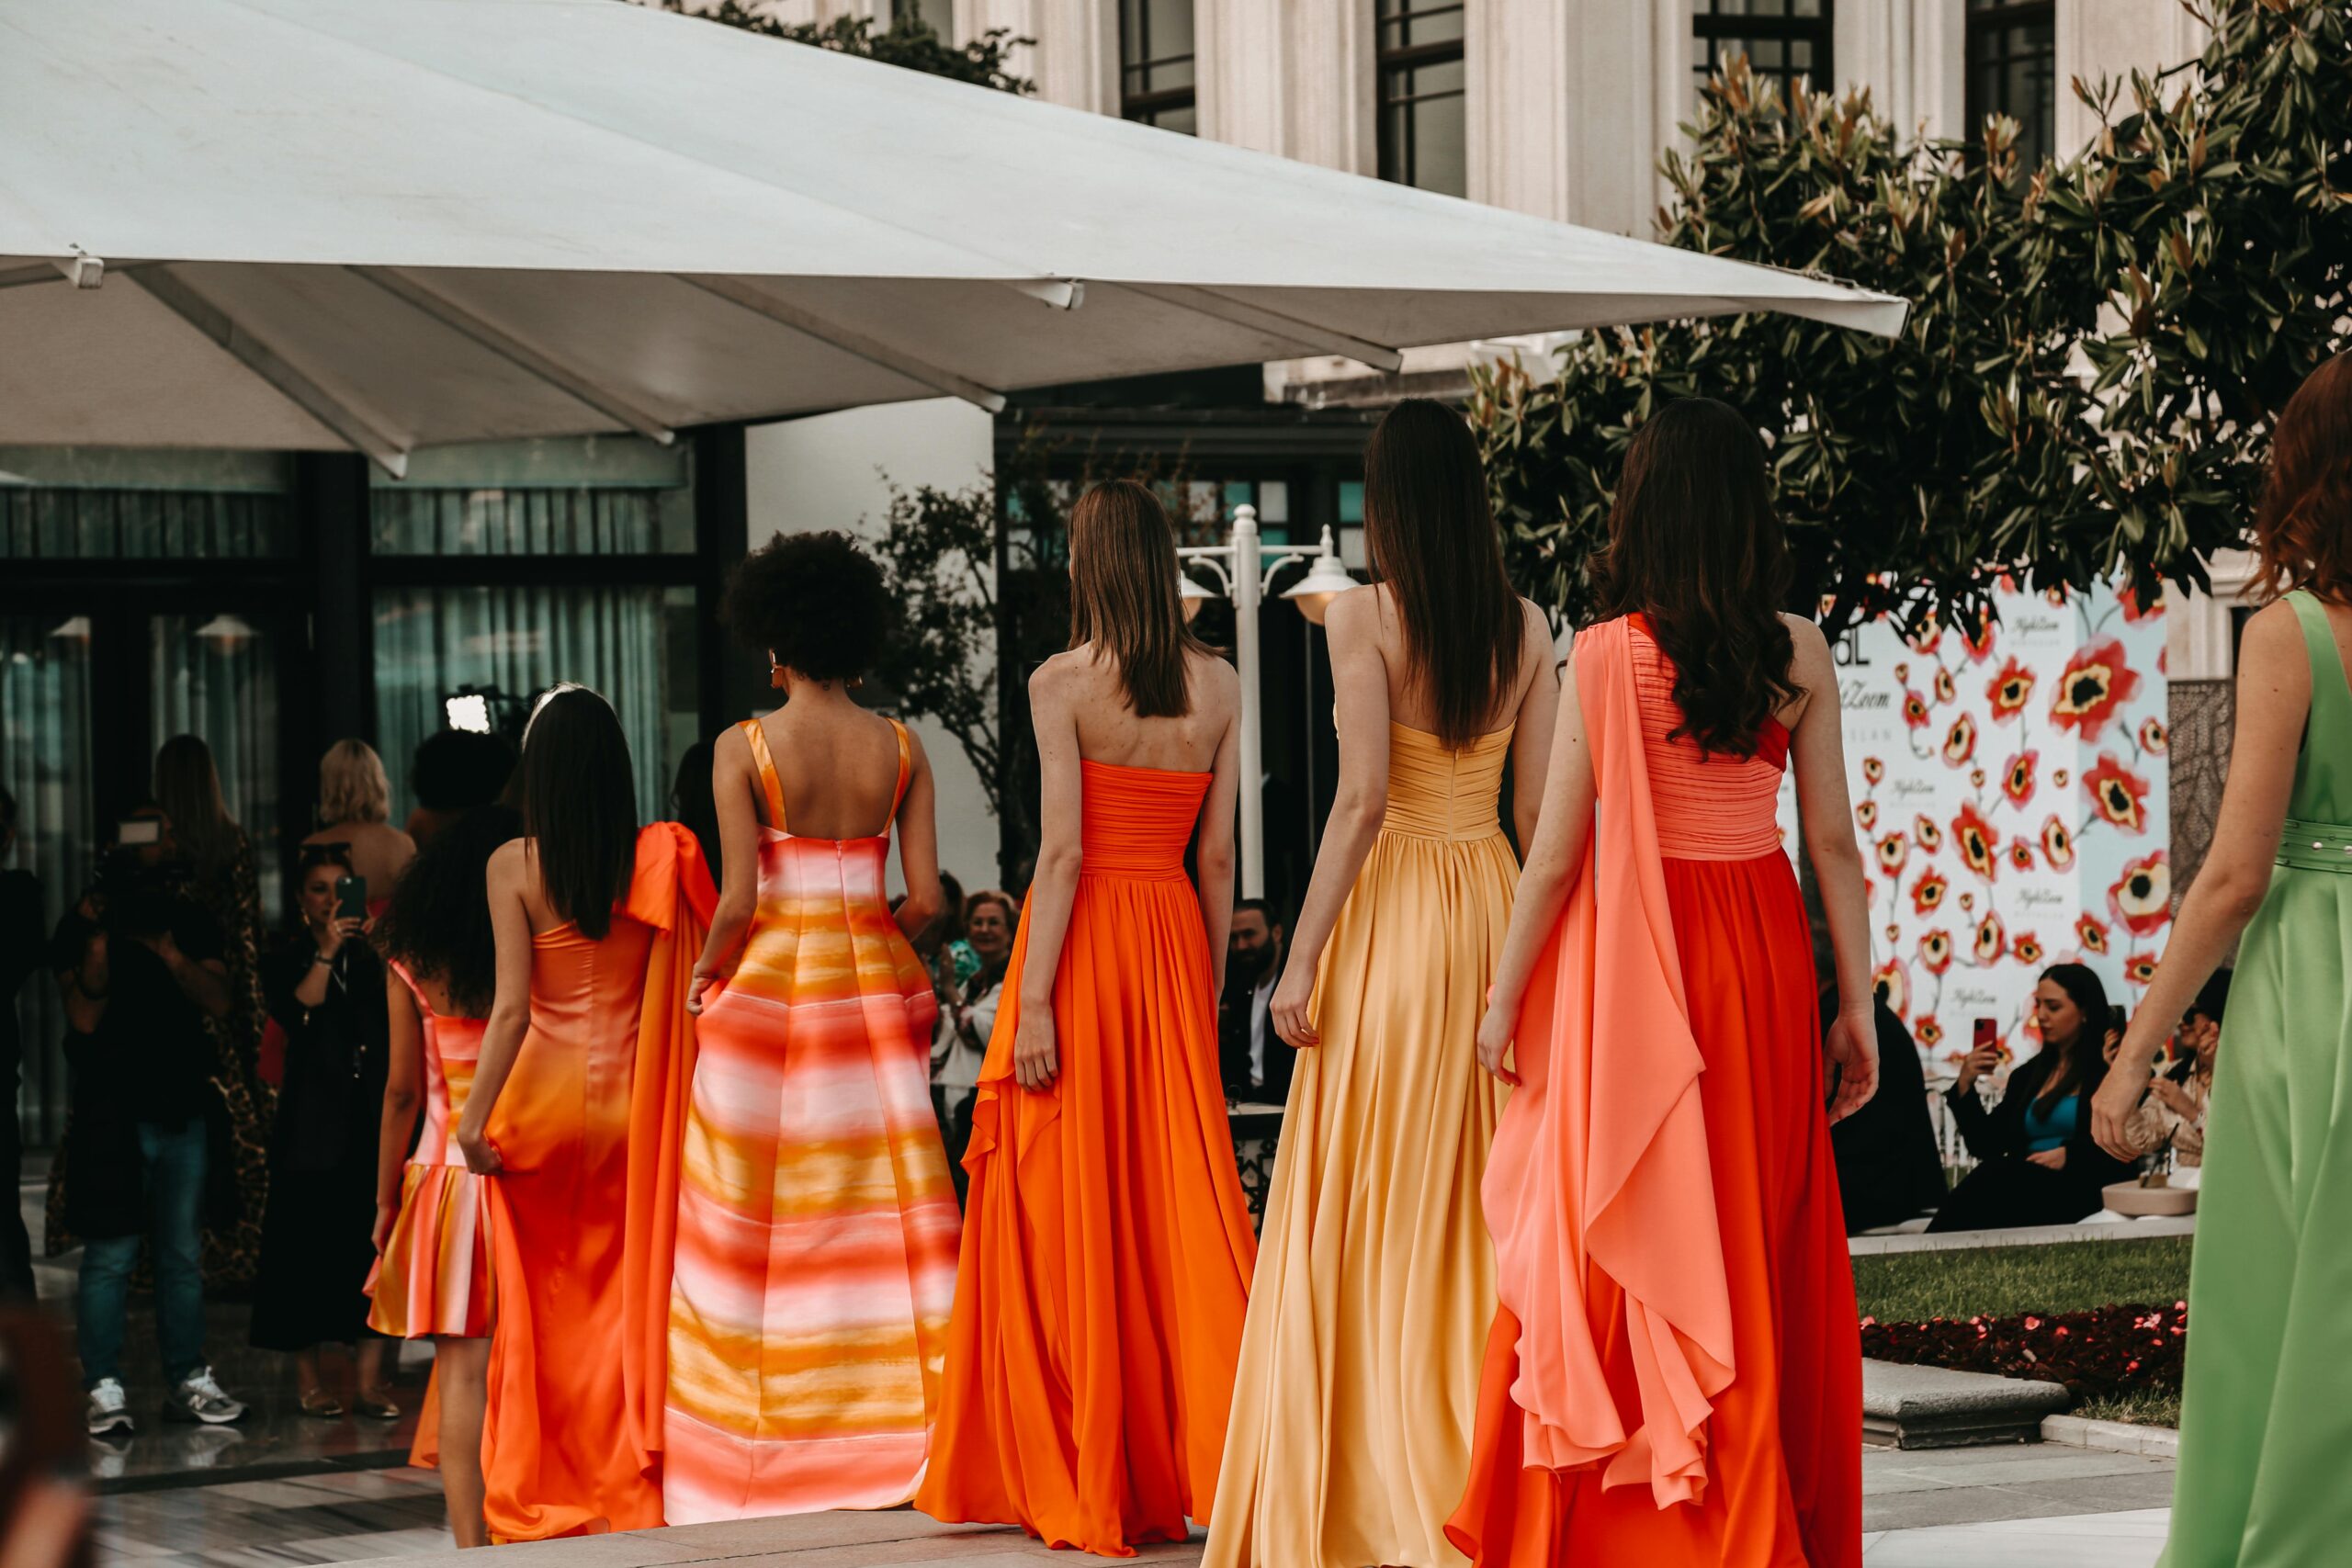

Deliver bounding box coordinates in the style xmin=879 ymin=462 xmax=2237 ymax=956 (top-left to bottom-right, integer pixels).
xmin=1788 ymin=616 xmax=1879 ymax=1122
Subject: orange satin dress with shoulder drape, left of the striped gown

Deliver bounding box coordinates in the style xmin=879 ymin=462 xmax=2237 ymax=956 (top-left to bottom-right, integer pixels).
xmin=482 ymin=823 xmax=718 ymax=1542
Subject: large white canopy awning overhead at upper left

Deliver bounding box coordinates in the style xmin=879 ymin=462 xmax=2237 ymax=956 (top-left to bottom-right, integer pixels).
xmin=0 ymin=0 xmax=1905 ymax=472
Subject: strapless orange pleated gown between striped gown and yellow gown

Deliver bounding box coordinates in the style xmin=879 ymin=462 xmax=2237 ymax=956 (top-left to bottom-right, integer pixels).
xmin=915 ymin=761 xmax=1259 ymax=1556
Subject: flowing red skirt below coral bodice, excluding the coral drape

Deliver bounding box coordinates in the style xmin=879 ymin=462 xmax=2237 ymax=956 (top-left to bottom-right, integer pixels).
xmin=1449 ymin=853 xmax=1863 ymax=1568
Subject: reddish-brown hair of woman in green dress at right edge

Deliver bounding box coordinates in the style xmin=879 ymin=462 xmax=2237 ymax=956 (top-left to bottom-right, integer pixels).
xmin=2253 ymin=353 xmax=2352 ymax=604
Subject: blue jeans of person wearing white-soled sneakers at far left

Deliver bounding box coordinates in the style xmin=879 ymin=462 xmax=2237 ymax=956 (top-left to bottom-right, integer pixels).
xmin=73 ymin=1117 xmax=205 ymax=1389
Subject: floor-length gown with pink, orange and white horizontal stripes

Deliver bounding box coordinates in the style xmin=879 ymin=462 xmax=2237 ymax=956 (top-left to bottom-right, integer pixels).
xmin=663 ymin=719 xmax=959 ymax=1523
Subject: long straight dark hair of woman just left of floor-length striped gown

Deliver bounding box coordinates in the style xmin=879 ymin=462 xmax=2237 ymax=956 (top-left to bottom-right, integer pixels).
xmin=513 ymin=682 xmax=638 ymax=942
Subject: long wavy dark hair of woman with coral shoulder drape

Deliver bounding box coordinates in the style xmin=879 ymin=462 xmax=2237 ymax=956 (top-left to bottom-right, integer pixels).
xmin=1592 ymin=398 xmax=1797 ymax=757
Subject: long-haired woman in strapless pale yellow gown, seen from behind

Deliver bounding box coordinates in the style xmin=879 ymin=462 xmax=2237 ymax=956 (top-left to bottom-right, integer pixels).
xmin=1204 ymin=398 xmax=1555 ymax=1568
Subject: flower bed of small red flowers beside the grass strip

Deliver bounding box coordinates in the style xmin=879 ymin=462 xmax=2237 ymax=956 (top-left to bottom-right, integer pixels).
xmin=1863 ymin=1303 xmax=2189 ymax=1404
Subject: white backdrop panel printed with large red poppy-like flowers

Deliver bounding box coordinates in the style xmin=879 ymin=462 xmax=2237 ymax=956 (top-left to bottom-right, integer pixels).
xmin=1837 ymin=583 xmax=2171 ymax=1084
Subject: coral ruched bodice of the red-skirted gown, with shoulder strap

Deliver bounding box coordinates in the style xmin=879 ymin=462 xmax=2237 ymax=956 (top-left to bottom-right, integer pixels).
xmin=1630 ymin=616 xmax=1788 ymax=861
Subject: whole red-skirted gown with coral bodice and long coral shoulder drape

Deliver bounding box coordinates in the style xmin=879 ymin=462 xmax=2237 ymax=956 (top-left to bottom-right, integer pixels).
xmin=1446 ymin=618 xmax=1863 ymax=1568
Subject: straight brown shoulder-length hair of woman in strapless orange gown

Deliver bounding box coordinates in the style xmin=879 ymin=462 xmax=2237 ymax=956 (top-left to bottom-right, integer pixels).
xmin=1070 ymin=479 xmax=1206 ymax=719
